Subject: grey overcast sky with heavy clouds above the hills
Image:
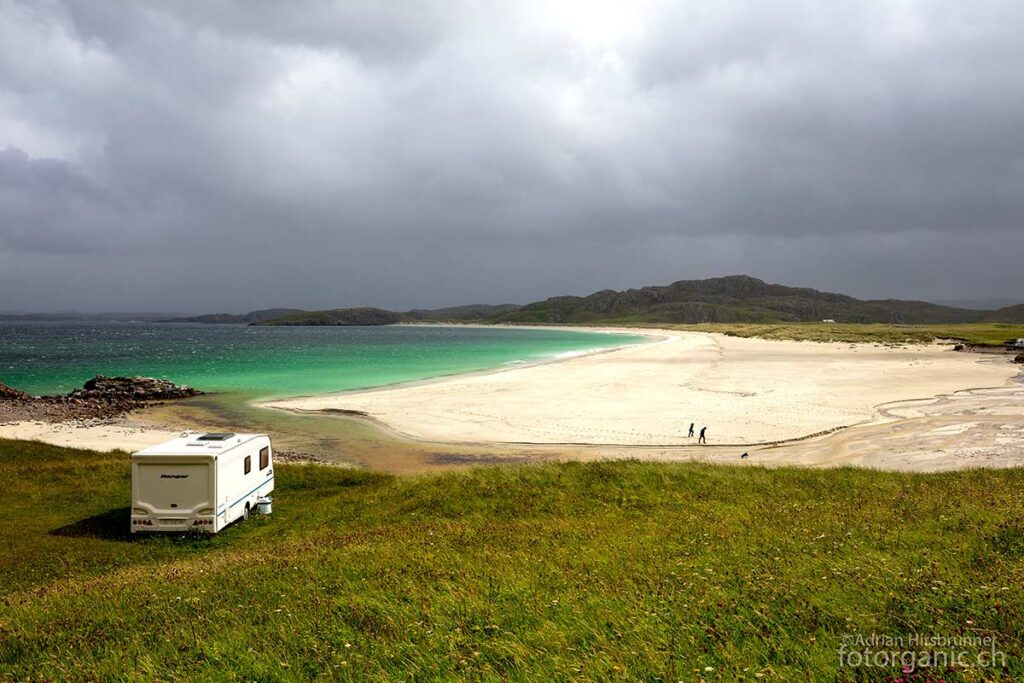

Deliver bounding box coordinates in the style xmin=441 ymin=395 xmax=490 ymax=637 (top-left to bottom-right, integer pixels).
xmin=0 ymin=0 xmax=1024 ymax=312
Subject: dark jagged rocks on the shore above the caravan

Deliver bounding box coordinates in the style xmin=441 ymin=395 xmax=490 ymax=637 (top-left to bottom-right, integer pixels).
xmin=0 ymin=375 xmax=203 ymax=422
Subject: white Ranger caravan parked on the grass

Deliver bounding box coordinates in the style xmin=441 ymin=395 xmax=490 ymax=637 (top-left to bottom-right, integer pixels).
xmin=131 ymin=432 xmax=273 ymax=533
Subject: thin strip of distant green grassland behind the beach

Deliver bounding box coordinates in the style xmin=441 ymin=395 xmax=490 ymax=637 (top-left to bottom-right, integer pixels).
xmin=643 ymin=323 xmax=1024 ymax=346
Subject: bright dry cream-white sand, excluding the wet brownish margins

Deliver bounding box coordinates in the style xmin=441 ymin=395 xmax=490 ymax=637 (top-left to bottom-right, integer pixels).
xmin=262 ymin=330 xmax=1017 ymax=445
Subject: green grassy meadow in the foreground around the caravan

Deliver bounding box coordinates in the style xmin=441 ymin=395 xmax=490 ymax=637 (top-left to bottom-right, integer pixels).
xmin=0 ymin=441 xmax=1024 ymax=681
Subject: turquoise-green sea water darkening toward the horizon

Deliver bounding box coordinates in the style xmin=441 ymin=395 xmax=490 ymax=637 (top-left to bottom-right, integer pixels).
xmin=0 ymin=323 xmax=644 ymax=397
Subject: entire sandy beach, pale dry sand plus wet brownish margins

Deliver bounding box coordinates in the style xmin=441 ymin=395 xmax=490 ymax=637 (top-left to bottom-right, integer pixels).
xmin=0 ymin=330 xmax=1024 ymax=473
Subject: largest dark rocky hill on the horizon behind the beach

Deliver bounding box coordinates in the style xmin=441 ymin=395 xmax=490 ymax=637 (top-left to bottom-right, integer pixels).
xmin=490 ymin=275 xmax=1024 ymax=324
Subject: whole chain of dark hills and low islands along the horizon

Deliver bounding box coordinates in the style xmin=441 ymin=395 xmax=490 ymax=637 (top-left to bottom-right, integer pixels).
xmin=188 ymin=275 xmax=1024 ymax=326
